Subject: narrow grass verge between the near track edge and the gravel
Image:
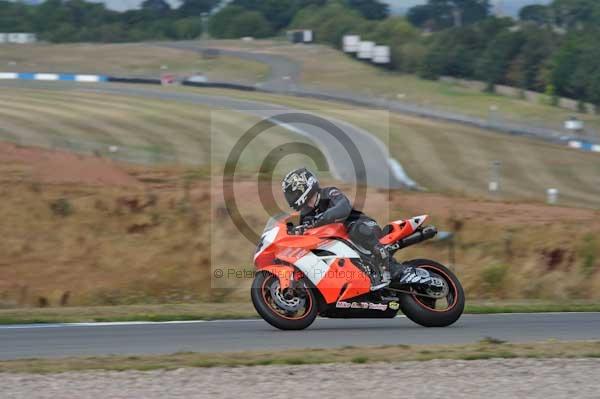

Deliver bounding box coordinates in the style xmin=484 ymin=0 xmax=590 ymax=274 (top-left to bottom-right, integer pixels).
xmin=0 ymin=338 xmax=600 ymax=373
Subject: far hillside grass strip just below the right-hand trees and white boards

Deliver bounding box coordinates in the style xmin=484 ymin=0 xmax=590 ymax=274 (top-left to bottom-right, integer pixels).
xmin=203 ymin=40 xmax=600 ymax=134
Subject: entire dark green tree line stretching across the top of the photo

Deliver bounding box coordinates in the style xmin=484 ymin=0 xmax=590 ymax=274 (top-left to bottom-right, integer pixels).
xmin=0 ymin=0 xmax=600 ymax=105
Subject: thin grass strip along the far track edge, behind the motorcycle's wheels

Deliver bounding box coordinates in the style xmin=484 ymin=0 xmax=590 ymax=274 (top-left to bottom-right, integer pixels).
xmin=0 ymin=301 xmax=600 ymax=324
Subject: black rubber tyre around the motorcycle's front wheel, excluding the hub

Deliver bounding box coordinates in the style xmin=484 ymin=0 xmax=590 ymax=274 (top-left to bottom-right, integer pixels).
xmin=250 ymin=271 xmax=318 ymax=330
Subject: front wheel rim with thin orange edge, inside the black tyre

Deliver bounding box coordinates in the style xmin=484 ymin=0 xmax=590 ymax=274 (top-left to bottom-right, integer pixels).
xmin=261 ymin=275 xmax=313 ymax=320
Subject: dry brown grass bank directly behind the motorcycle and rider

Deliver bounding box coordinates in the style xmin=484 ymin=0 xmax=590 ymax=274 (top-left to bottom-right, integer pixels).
xmin=0 ymin=144 xmax=600 ymax=307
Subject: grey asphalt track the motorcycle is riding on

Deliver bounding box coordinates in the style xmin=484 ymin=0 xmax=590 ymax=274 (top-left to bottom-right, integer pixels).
xmin=0 ymin=313 xmax=600 ymax=360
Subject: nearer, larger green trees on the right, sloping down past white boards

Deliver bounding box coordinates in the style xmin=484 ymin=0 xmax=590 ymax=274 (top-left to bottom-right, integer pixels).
xmin=290 ymin=0 xmax=600 ymax=110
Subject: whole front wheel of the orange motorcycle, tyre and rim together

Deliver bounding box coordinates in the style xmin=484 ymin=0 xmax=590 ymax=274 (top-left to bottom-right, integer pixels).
xmin=250 ymin=271 xmax=318 ymax=330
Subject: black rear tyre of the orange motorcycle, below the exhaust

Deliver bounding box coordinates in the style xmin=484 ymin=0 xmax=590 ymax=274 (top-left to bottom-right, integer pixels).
xmin=399 ymin=259 xmax=465 ymax=327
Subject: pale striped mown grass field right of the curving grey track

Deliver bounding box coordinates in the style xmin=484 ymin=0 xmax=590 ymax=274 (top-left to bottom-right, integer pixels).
xmin=164 ymin=88 xmax=600 ymax=208
